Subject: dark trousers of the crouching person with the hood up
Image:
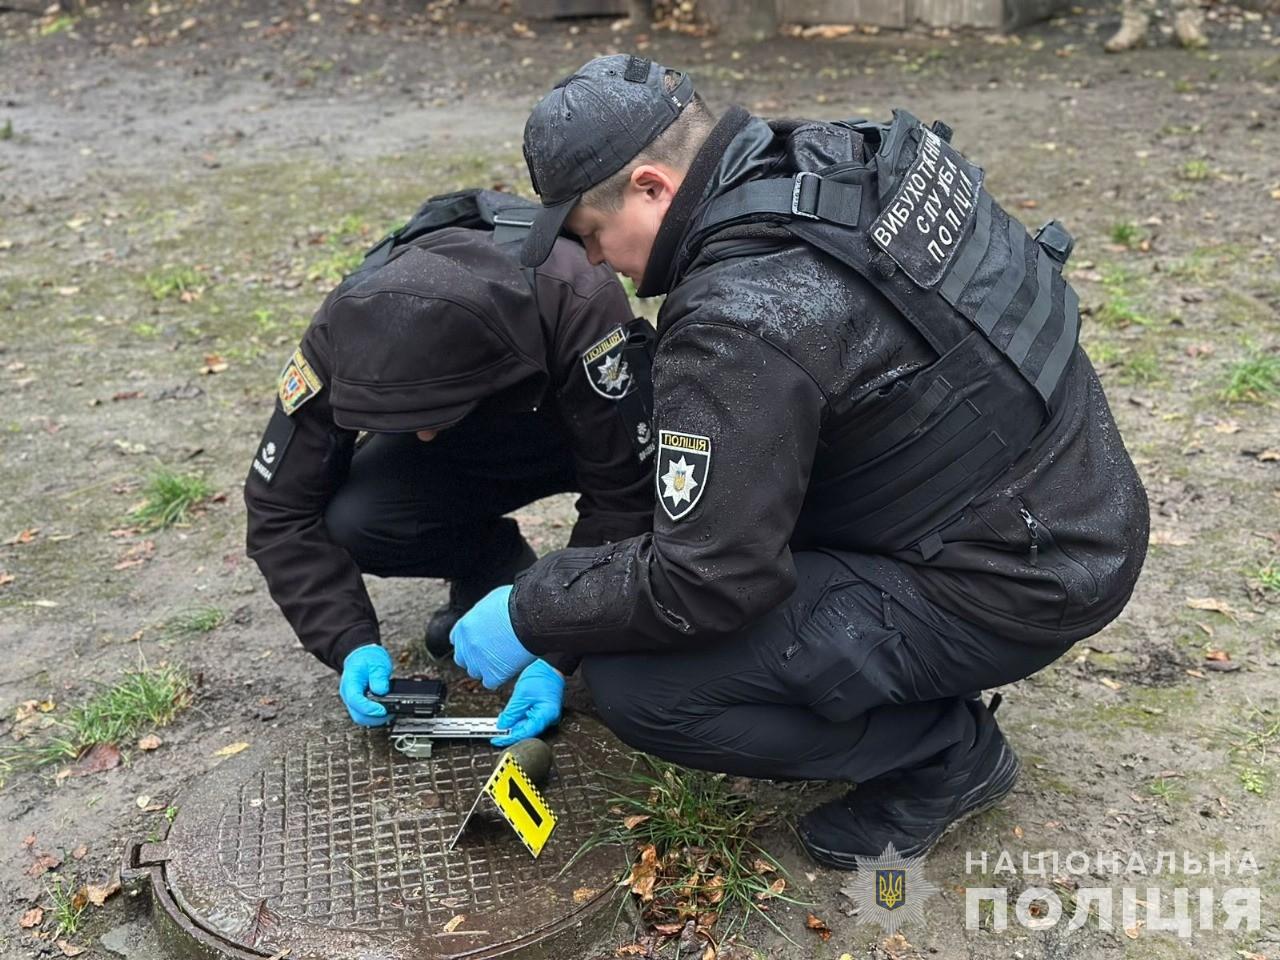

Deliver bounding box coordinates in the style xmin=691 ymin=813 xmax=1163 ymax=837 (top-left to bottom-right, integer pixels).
xmin=325 ymin=412 xmax=577 ymax=579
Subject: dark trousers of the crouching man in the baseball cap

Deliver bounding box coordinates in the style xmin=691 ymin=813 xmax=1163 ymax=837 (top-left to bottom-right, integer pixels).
xmin=581 ymin=550 xmax=1068 ymax=783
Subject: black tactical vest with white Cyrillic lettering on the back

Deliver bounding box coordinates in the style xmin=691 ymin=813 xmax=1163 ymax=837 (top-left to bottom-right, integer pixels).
xmin=696 ymin=110 xmax=1079 ymax=559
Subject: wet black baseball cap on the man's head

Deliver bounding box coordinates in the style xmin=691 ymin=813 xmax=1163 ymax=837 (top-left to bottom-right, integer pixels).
xmin=520 ymin=54 xmax=694 ymax=266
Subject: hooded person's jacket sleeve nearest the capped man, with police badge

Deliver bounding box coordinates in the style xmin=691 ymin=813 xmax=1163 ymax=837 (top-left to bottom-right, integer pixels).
xmin=553 ymin=268 xmax=653 ymax=547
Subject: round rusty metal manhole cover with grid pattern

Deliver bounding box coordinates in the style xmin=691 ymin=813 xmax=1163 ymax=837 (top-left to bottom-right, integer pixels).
xmin=125 ymin=717 xmax=625 ymax=960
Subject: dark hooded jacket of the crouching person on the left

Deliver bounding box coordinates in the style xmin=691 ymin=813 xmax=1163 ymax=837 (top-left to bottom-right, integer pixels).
xmin=244 ymin=228 xmax=653 ymax=669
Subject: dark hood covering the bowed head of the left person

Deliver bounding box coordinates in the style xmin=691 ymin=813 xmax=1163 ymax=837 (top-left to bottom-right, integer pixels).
xmin=321 ymin=228 xmax=548 ymax=433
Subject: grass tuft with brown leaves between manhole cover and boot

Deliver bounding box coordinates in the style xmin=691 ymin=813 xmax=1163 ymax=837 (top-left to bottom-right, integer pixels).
xmin=575 ymin=756 xmax=799 ymax=936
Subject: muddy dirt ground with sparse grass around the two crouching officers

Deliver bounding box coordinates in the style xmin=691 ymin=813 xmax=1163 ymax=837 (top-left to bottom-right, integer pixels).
xmin=0 ymin=0 xmax=1280 ymax=960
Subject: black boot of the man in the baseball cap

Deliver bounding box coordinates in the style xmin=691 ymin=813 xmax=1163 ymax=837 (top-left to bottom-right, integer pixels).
xmin=799 ymin=700 xmax=1021 ymax=870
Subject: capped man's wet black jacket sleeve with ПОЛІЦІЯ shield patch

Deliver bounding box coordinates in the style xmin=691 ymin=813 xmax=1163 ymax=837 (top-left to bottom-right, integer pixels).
xmin=511 ymin=320 xmax=824 ymax=654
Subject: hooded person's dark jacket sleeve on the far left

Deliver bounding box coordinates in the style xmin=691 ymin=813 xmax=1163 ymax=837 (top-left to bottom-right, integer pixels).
xmin=244 ymin=326 xmax=379 ymax=669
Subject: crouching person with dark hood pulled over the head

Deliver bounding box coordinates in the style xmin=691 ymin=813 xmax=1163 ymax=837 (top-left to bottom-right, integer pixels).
xmin=244 ymin=191 xmax=654 ymax=724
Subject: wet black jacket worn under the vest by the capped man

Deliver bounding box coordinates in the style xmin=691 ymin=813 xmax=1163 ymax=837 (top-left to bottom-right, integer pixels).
xmin=512 ymin=110 xmax=1148 ymax=654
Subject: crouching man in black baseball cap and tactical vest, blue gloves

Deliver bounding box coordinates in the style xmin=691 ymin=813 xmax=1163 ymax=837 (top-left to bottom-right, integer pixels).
xmin=453 ymin=56 xmax=1148 ymax=868
